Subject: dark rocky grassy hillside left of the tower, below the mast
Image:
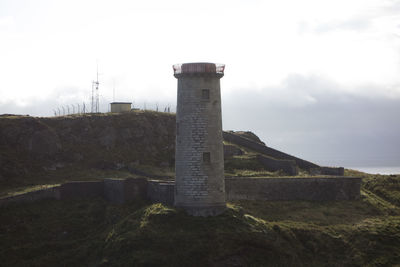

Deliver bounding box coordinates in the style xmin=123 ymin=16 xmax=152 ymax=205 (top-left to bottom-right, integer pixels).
xmin=0 ymin=111 xmax=175 ymax=194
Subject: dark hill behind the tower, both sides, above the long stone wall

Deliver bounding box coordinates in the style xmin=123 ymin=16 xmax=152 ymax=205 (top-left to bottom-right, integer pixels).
xmin=0 ymin=110 xmax=338 ymax=193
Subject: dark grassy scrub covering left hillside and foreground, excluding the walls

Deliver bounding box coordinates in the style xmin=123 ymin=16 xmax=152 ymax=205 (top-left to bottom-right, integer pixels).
xmin=0 ymin=112 xmax=400 ymax=266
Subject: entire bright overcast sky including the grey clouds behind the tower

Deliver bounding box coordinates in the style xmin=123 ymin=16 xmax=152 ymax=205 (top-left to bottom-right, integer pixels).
xmin=0 ymin=0 xmax=400 ymax=167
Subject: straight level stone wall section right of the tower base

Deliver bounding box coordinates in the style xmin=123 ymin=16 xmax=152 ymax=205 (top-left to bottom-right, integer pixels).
xmin=225 ymin=177 xmax=361 ymax=201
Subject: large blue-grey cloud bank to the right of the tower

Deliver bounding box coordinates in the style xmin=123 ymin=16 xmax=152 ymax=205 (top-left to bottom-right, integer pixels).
xmin=223 ymin=75 xmax=400 ymax=167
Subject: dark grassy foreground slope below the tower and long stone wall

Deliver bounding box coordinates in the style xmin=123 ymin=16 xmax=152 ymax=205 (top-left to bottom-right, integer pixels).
xmin=0 ymin=176 xmax=400 ymax=266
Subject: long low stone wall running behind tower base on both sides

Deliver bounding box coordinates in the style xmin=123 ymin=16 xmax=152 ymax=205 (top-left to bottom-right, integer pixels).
xmin=0 ymin=177 xmax=361 ymax=205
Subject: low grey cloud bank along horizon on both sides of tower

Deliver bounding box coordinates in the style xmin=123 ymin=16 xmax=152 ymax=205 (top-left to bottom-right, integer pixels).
xmin=0 ymin=74 xmax=400 ymax=167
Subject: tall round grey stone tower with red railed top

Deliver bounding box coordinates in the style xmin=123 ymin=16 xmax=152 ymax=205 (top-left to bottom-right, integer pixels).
xmin=173 ymin=63 xmax=226 ymax=216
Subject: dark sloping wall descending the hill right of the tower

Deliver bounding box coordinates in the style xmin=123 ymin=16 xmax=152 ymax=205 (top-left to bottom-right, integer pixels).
xmin=223 ymin=132 xmax=319 ymax=170
